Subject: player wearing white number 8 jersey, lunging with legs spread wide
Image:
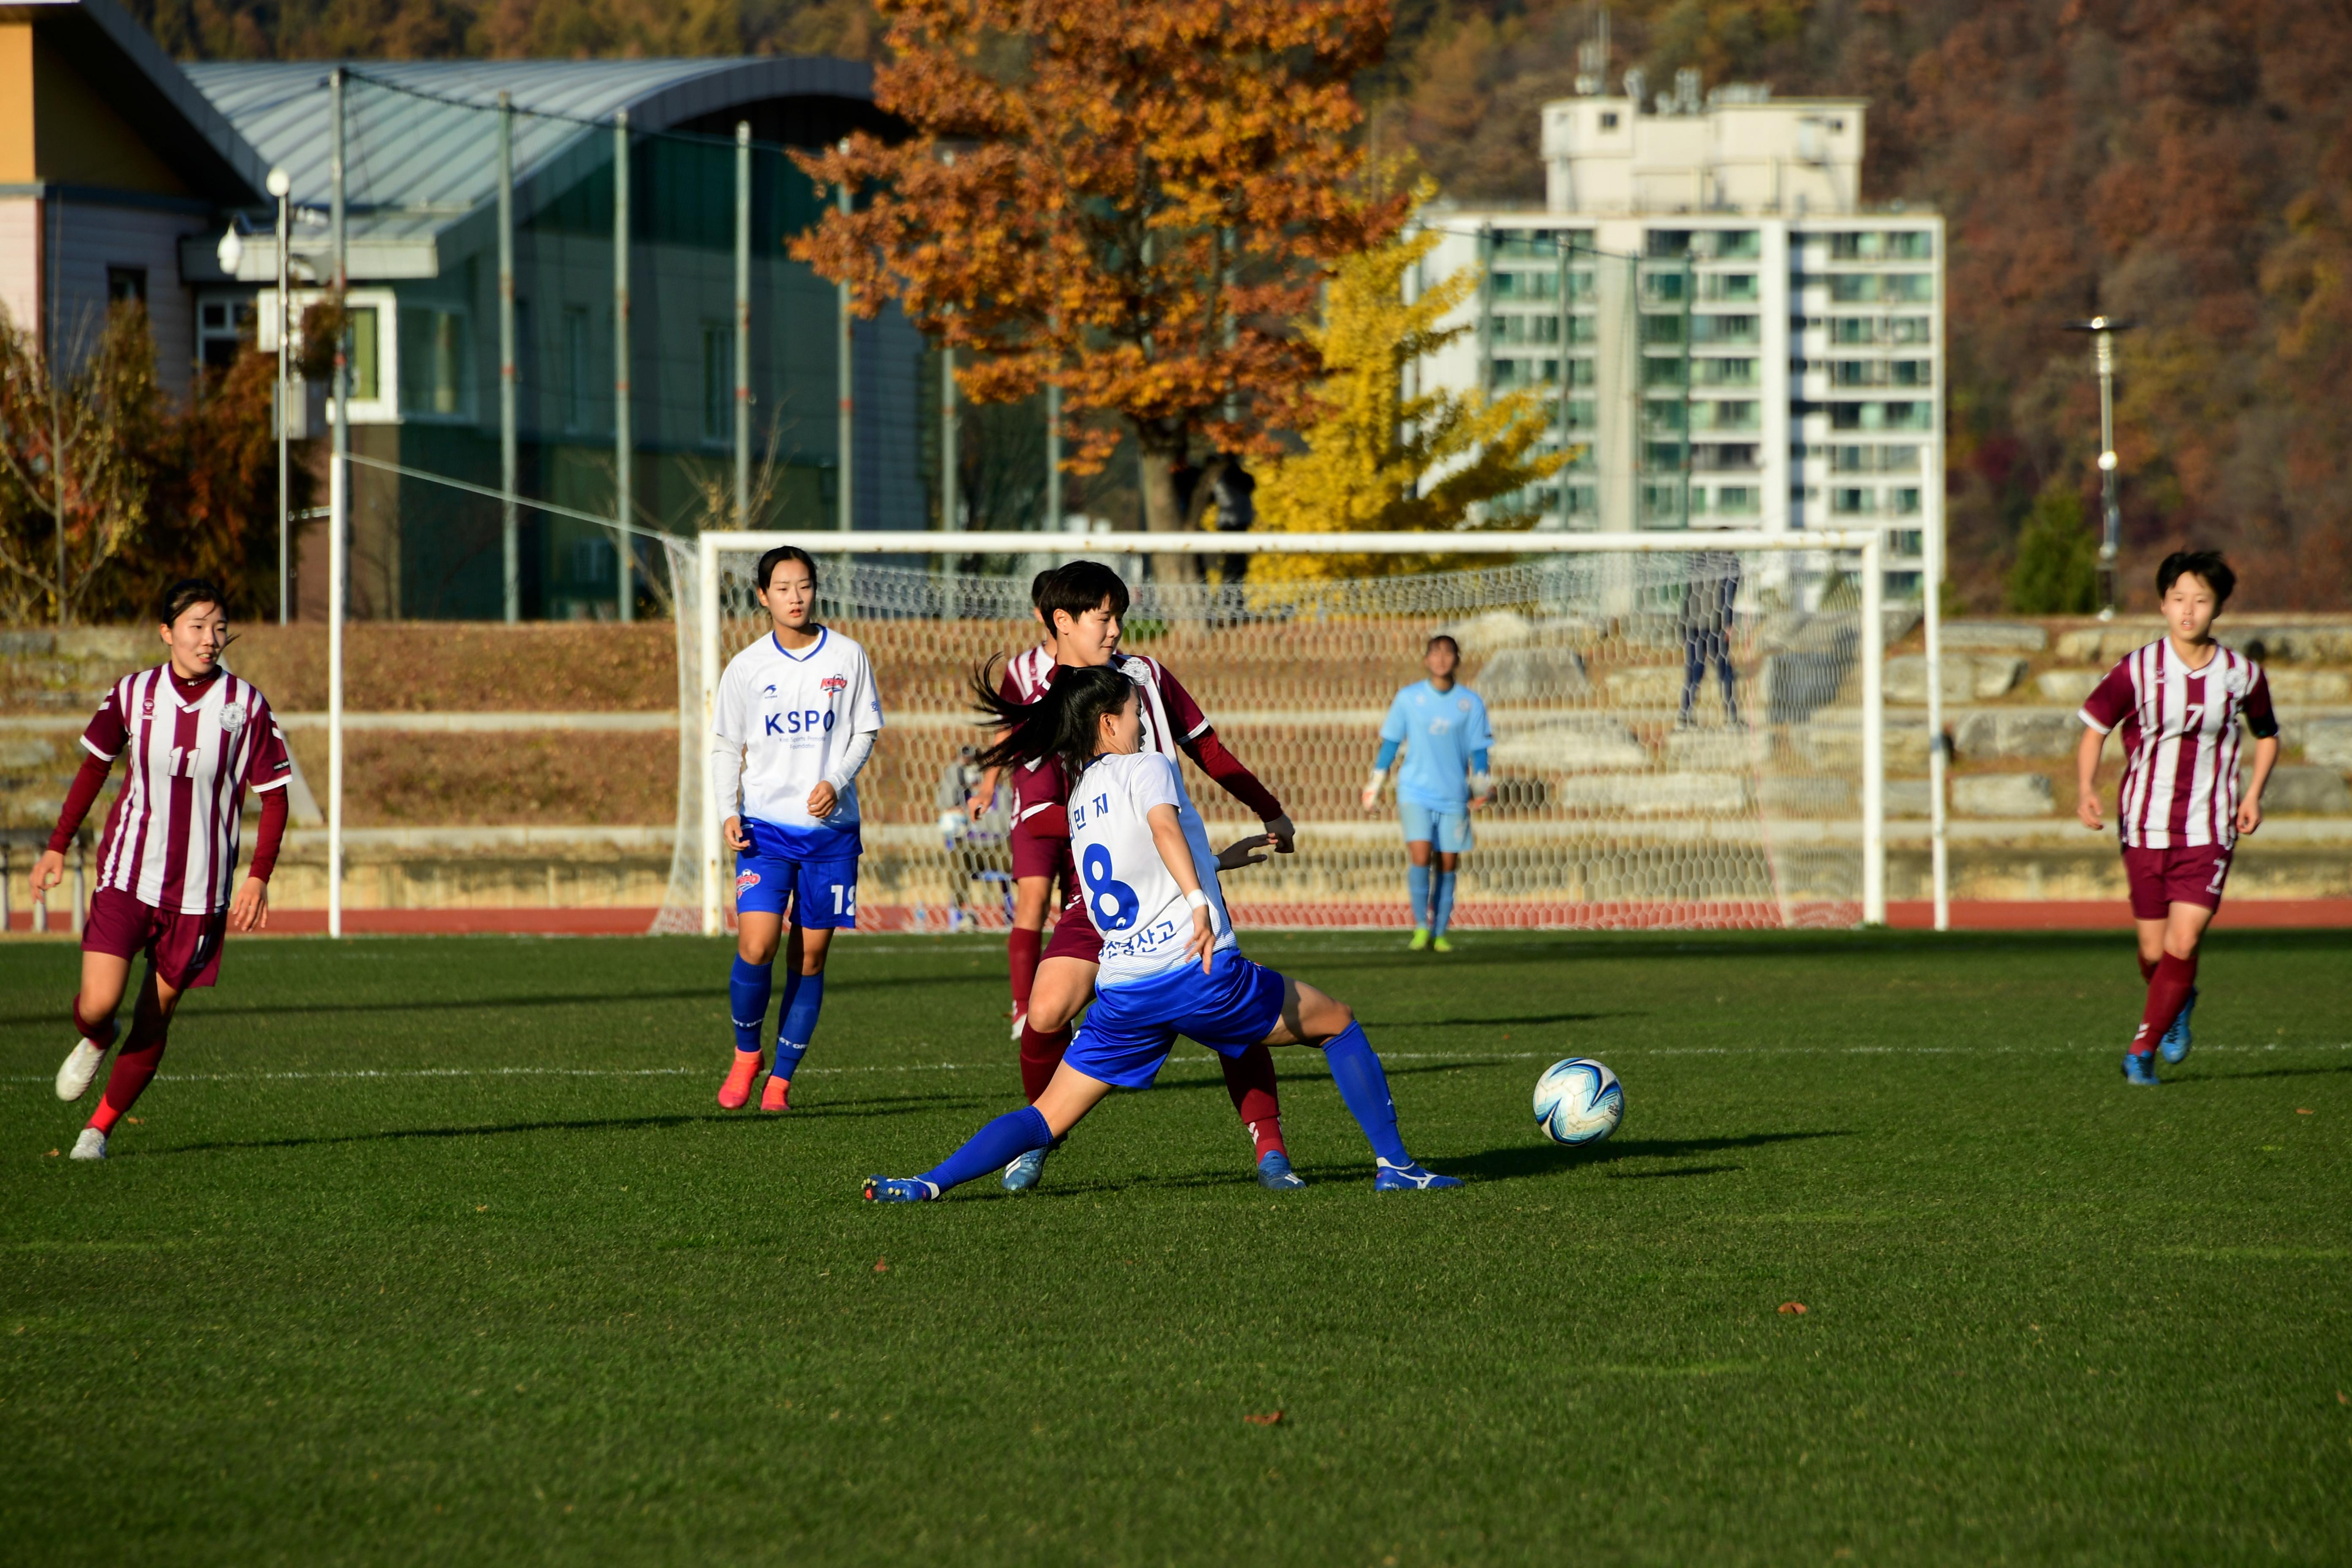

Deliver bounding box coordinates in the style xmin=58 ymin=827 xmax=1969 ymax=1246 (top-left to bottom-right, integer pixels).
xmin=866 ymin=665 xmax=1461 ymax=1203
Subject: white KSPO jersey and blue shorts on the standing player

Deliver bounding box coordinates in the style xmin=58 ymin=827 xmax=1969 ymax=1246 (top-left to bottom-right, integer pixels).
xmin=710 ymin=628 xmax=882 ymax=926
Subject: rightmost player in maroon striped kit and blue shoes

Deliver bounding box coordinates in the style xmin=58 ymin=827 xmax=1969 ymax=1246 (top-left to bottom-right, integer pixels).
xmin=2074 ymin=550 xmax=2279 ymax=1084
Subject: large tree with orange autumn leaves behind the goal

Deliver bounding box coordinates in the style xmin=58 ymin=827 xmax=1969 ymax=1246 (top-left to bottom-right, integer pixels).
xmin=792 ymin=0 xmax=1409 ymax=545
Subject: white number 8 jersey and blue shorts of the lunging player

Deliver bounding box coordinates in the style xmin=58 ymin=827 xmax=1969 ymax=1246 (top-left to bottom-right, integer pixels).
xmin=1065 ymin=752 xmax=1282 ymax=1089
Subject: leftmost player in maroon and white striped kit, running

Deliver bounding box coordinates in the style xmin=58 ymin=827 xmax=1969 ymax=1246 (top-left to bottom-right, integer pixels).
xmin=33 ymin=578 xmax=294 ymax=1159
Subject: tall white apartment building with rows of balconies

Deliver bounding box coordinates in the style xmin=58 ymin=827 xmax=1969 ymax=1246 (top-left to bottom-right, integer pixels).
xmin=1413 ymin=73 xmax=1945 ymax=595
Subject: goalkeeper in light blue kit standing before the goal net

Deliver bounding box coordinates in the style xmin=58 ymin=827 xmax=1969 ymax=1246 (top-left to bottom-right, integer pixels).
xmin=1364 ymin=632 xmax=1494 ymax=952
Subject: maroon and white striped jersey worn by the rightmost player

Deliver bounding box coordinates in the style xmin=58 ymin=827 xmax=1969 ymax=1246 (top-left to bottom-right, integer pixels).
xmin=2079 ymin=637 xmax=2279 ymax=849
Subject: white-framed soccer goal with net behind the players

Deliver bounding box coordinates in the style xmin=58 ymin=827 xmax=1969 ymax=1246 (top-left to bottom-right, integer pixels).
xmin=654 ymin=529 xmax=1893 ymax=933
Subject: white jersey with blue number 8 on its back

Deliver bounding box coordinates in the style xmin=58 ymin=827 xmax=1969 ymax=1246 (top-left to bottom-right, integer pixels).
xmin=1070 ymin=752 xmax=1239 ymax=990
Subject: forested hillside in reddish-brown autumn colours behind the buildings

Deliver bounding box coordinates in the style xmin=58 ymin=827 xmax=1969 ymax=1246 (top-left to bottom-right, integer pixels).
xmin=134 ymin=0 xmax=2352 ymax=609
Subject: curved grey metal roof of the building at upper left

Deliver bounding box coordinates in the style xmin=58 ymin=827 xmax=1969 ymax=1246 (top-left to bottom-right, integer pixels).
xmin=181 ymin=57 xmax=873 ymax=219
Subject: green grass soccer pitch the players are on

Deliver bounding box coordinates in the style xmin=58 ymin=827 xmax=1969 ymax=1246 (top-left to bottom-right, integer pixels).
xmin=0 ymin=933 xmax=2352 ymax=1568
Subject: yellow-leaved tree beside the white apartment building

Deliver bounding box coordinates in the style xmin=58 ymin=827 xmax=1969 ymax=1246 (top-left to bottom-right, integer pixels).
xmin=1251 ymin=230 xmax=1573 ymax=578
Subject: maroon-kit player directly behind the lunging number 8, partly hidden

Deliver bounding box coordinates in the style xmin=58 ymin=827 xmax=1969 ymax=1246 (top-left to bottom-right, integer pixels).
xmin=976 ymin=562 xmax=1305 ymax=1192
